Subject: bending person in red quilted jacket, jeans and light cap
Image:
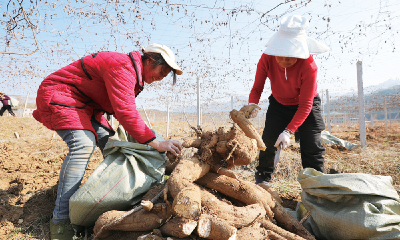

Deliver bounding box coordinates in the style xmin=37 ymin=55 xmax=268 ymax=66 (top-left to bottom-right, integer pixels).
xmin=33 ymin=44 xmax=182 ymax=239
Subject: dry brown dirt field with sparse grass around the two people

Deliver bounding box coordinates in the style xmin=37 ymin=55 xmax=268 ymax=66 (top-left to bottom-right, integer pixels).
xmin=0 ymin=117 xmax=400 ymax=240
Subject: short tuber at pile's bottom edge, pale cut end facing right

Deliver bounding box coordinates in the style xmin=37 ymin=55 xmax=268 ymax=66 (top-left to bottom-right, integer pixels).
xmin=160 ymin=217 xmax=197 ymax=238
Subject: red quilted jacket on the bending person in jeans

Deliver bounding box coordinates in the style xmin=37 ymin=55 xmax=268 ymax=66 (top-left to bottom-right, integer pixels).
xmin=33 ymin=51 xmax=155 ymax=143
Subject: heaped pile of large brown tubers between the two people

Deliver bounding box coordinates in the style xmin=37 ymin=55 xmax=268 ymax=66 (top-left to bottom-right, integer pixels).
xmin=94 ymin=106 xmax=315 ymax=240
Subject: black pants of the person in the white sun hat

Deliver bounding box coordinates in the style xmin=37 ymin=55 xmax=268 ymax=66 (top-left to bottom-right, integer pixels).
xmin=257 ymin=95 xmax=325 ymax=181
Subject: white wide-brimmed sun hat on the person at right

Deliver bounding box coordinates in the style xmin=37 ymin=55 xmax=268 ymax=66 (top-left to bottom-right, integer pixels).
xmin=264 ymin=15 xmax=329 ymax=59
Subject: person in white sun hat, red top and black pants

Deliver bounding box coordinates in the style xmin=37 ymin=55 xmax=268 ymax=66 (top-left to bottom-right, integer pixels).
xmin=249 ymin=16 xmax=329 ymax=186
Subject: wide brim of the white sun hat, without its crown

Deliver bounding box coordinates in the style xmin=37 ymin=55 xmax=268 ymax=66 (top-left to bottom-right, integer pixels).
xmin=264 ymin=32 xmax=329 ymax=59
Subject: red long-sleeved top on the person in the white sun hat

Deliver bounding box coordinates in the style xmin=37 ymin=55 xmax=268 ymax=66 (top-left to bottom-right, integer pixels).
xmin=249 ymin=53 xmax=318 ymax=132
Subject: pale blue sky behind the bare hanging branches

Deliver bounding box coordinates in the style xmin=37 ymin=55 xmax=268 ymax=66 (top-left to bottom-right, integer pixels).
xmin=0 ymin=0 xmax=400 ymax=109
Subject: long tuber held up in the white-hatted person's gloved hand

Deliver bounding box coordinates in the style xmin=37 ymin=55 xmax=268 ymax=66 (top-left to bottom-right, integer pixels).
xmin=229 ymin=109 xmax=266 ymax=151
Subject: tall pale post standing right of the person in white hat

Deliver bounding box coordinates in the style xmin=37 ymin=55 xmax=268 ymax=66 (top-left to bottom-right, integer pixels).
xmin=357 ymin=61 xmax=367 ymax=148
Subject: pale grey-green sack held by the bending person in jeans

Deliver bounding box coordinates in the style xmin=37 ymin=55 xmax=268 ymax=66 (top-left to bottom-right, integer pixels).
xmin=69 ymin=126 xmax=166 ymax=227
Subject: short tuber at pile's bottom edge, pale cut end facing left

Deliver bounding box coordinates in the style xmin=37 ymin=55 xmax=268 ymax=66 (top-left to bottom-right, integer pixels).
xmin=197 ymin=214 xmax=237 ymax=240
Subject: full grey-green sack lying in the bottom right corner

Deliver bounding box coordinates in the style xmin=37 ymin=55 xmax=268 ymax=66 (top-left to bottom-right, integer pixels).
xmin=296 ymin=168 xmax=400 ymax=240
